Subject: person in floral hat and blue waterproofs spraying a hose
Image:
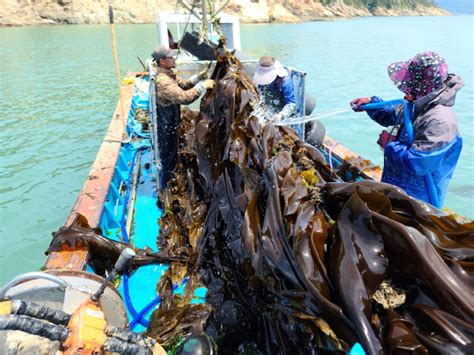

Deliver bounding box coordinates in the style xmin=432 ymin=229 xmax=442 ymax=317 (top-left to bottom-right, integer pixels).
xmin=350 ymin=52 xmax=464 ymax=204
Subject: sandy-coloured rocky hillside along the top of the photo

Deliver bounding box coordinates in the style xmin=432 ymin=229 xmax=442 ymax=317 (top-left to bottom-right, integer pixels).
xmin=0 ymin=0 xmax=449 ymax=26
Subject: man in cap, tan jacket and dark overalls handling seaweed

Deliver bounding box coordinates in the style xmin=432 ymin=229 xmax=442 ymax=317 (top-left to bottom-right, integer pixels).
xmin=152 ymin=47 xmax=215 ymax=189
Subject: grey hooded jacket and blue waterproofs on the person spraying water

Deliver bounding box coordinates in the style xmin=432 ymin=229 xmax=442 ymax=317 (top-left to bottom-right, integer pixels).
xmin=367 ymin=75 xmax=464 ymax=203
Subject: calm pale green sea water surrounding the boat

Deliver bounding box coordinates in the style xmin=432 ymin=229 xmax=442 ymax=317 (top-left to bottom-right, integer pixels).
xmin=0 ymin=16 xmax=474 ymax=285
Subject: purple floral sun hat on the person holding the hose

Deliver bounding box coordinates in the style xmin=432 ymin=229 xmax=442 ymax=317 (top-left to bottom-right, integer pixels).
xmin=387 ymin=52 xmax=448 ymax=99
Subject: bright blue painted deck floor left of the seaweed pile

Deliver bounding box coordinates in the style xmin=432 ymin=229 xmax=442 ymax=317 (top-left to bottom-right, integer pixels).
xmin=95 ymin=77 xmax=207 ymax=332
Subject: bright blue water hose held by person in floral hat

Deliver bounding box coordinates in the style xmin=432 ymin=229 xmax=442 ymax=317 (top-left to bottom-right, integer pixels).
xmin=360 ymin=99 xmax=442 ymax=208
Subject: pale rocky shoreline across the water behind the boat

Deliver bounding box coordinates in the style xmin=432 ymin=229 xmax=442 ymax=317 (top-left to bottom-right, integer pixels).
xmin=0 ymin=0 xmax=452 ymax=27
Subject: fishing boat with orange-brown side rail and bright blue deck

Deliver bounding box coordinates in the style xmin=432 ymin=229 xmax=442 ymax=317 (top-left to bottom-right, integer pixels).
xmin=0 ymin=5 xmax=472 ymax=354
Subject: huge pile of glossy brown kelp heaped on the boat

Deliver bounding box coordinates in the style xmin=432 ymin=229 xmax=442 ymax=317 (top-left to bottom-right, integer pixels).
xmin=148 ymin=54 xmax=474 ymax=354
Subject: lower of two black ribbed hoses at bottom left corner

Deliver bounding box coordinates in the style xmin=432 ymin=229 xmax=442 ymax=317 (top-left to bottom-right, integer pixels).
xmin=0 ymin=315 xmax=69 ymax=343
